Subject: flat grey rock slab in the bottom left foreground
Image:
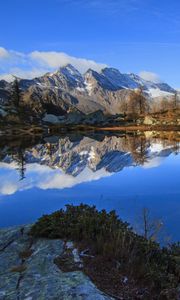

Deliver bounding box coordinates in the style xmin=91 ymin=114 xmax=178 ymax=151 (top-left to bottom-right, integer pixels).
xmin=0 ymin=226 xmax=112 ymax=300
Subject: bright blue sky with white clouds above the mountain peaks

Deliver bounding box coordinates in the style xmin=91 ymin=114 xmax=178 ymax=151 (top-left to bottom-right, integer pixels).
xmin=0 ymin=0 xmax=180 ymax=87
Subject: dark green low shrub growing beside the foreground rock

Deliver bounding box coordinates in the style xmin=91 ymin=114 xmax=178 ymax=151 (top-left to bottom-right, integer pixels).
xmin=30 ymin=204 xmax=180 ymax=290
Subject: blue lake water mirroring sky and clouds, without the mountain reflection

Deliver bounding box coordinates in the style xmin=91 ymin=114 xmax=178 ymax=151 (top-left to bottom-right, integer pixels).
xmin=0 ymin=136 xmax=180 ymax=242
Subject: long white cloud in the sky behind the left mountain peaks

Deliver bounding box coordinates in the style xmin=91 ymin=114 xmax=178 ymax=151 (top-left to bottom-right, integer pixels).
xmin=0 ymin=47 xmax=106 ymax=81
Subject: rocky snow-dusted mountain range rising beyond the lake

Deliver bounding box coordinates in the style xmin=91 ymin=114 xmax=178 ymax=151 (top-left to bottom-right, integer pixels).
xmin=0 ymin=64 xmax=176 ymax=122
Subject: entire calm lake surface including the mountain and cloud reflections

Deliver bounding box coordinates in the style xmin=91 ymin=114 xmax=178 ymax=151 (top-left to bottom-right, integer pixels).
xmin=0 ymin=133 xmax=180 ymax=242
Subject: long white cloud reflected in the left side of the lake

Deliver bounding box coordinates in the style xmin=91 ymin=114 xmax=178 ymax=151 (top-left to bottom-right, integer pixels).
xmin=0 ymin=163 xmax=112 ymax=195
